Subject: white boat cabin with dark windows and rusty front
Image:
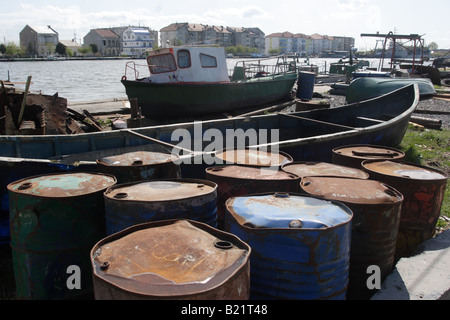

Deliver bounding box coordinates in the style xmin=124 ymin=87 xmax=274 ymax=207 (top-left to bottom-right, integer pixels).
xmin=147 ymin=47 xmax=230 ymax=83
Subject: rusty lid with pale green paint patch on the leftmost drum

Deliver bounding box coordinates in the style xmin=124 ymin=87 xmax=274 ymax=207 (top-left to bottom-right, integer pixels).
xmin=8 ymin=172 xmax=116 ymax=198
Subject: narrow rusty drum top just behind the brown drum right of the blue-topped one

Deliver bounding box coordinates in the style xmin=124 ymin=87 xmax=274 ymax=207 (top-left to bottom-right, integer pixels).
xmin=281 ymin=161 xmax=369 ymax=179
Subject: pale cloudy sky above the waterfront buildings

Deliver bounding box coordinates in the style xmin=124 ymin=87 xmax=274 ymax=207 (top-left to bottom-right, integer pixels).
xmin=0 ymin=0 xmax=450 ymax=51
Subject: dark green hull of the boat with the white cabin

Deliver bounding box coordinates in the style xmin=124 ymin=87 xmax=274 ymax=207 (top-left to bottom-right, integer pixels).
xmin=122 ymin=72 xmax=297 ymax=119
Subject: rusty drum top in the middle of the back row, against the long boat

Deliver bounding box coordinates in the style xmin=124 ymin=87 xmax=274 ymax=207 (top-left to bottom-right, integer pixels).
xmin=214 ymin=148 xmax=293 ymax=167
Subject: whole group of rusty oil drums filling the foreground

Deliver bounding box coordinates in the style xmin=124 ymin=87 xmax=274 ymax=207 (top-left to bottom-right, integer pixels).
xmin=8 ymin=145 xmax=447 ymax=300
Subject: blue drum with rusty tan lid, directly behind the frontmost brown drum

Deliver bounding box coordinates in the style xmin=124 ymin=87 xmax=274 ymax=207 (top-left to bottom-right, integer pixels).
xmin=104 ymin=179 xmax=217 ymax=235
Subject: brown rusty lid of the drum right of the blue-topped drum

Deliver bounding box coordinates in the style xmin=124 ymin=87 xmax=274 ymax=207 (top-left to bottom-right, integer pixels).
xmin=300 ymin=177 xmax=403 ymax=205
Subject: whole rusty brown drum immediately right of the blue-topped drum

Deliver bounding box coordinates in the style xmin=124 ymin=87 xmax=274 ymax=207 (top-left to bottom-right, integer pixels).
xmin=301 ymin=177 xmax=403 ymax=299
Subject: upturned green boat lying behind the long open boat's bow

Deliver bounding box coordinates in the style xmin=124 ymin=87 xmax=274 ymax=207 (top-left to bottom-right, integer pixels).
xmin=346 ymin=77 xmax=436 ymax=103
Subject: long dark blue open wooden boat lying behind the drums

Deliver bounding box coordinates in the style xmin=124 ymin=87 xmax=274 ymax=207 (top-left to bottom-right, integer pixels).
xmin=0 ymin=84 xmax=419 ymax=241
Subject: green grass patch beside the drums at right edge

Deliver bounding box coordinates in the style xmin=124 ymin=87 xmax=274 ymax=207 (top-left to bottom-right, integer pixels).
xmin=398 ymin=126 xmax=450 ymax=229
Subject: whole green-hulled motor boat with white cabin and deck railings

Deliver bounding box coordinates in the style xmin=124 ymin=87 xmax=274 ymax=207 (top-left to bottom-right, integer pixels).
xmin=121 ymin=47 xmax=297 ymax=119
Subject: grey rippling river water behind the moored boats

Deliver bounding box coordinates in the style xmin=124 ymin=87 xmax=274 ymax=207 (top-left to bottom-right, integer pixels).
xmin=0 ymin=58 xmax=378 ymax=103
